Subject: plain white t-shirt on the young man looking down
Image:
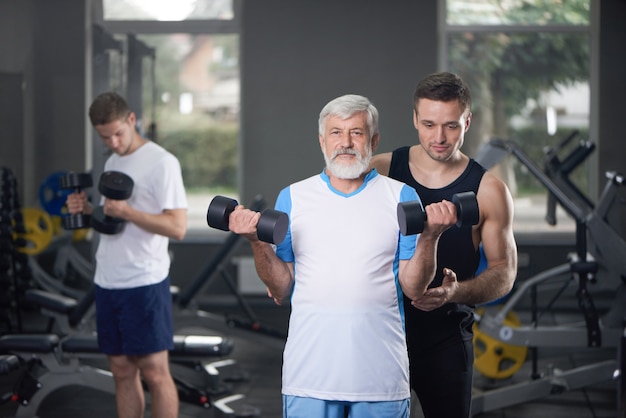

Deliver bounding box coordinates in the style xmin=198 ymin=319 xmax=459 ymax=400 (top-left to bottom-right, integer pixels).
xmin=94 ymin=142 xmax=187 ymax=289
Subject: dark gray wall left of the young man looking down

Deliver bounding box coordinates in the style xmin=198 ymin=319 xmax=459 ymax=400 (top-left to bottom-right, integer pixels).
xmin=0 ymin=0 xmax=88 ymax=206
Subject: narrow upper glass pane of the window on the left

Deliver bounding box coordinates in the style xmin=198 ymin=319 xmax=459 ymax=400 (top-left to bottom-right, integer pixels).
xmin=102 ymin=0 xmax=234 ymax=21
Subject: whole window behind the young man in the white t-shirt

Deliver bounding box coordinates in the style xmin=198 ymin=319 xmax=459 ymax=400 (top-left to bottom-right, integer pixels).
xmin=96 ymin=0 xmax=240 ymax=234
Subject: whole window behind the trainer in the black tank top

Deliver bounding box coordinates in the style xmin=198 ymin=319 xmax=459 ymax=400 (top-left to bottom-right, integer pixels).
xmin=441 ymin=0 xmax=593 ymax=232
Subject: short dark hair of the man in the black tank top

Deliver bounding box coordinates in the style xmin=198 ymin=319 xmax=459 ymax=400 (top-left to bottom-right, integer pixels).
xmin=413 ymin=72 xmax=472 ymax=111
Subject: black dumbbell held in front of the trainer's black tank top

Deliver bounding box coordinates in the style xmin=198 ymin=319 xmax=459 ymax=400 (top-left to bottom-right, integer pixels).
xmin=398 ymin=191 xmax=479 ymax=235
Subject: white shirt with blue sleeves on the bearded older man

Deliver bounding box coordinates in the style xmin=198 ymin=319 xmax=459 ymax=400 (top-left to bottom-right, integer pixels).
xmin=276 ymin=170 xmax=418 ymax=402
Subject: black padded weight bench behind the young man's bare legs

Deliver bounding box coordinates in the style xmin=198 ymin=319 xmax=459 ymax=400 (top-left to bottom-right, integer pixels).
xmin=0 ymin=334 xmax=232 ymax=418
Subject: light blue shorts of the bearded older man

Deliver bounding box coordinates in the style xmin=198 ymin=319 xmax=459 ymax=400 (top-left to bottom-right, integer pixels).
xmin=283 ymin=395 xmax=411 ymax=418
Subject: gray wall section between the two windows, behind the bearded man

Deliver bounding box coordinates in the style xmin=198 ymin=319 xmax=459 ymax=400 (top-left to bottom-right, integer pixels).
xmin=240 ymin=0 xmax=437 ymax=206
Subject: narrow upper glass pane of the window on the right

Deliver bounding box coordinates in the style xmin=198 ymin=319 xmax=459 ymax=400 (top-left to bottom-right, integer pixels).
xmin=446 ymin=0 xmax=590 ymax=25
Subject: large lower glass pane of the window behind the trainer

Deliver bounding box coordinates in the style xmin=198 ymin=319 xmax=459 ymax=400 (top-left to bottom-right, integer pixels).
xmin=447 ymin=32 xmax=590 ymax=231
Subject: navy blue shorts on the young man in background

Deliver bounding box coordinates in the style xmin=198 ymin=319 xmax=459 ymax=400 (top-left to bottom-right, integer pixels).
xmin=96 ymin=277 xmax=174 ymax=356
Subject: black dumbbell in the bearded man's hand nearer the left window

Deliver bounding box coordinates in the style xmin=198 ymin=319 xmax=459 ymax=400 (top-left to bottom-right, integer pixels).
xmin=206 ymin=196 xmax=289 ymax=244
